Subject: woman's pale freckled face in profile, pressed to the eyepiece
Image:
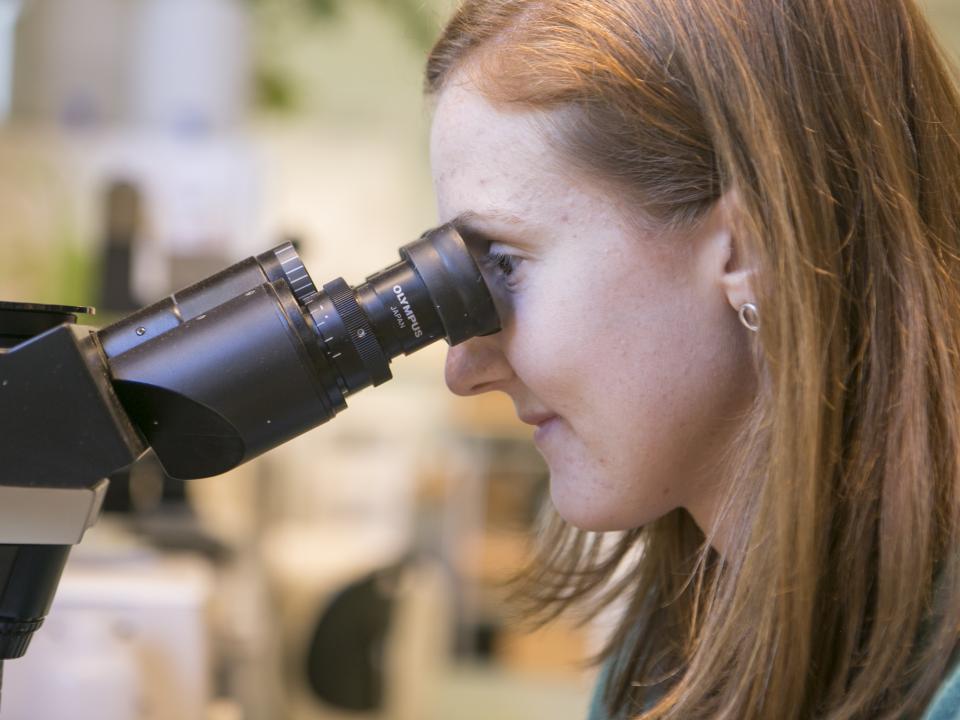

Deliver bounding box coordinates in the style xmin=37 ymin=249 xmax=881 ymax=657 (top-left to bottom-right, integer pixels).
xmin=431 ymin=73 xmax=753 ymax=530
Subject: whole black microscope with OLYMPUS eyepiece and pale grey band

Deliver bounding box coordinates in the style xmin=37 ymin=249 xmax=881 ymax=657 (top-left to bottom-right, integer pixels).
xmin=0 ymin=225 xmax=500 ymax=696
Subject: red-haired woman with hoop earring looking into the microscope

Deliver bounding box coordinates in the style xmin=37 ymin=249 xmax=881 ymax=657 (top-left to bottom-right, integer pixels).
xmin=427 ymin=0 xmax=960 ymax=720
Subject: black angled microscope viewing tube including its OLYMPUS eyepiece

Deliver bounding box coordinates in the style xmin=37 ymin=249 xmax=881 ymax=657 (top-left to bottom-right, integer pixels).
xmin=98 ymin=225 xmax=500 ymax=479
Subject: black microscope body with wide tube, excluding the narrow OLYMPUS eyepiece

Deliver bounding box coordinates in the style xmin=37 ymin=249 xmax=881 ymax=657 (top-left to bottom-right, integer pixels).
xmin=0 ymin=245 xmax=346 ymax=660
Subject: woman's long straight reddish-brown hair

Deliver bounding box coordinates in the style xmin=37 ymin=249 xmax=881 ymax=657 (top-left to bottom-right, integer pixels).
xmin=426 ymin=0 xmax=960 ymax=720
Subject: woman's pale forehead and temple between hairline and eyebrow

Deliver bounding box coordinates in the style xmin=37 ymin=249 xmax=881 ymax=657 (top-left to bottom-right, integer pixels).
xmin=430 ymin=74 xmax=683 ymax=280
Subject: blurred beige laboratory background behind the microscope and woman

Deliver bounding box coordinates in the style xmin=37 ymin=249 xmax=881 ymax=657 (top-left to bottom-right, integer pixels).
xmin=0 ymin=0 xmax=960 ymax=720
